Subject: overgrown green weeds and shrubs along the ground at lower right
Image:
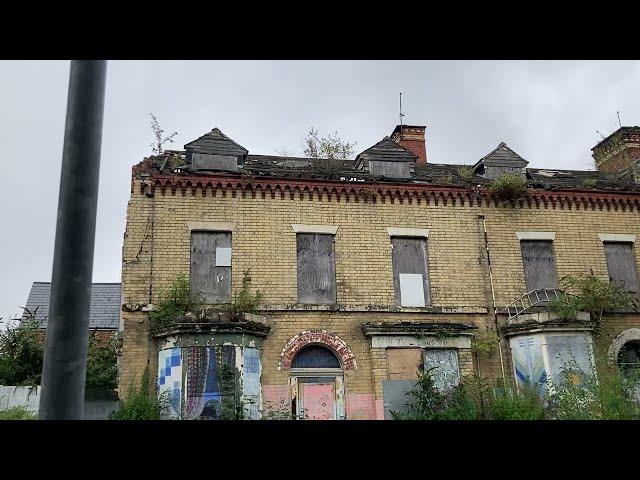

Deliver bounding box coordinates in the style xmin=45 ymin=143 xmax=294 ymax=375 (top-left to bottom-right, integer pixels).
xmin=392 ymin=344 xmax=640 ymax=420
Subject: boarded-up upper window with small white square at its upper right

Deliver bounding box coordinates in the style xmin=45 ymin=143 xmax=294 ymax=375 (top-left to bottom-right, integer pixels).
xmin=190 ymin=232 xmax=231 ymax=303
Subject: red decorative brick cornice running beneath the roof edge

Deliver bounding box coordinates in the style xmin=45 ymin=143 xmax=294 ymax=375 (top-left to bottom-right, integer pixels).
xmin=139 ymin=174 xmax=640 ymax=211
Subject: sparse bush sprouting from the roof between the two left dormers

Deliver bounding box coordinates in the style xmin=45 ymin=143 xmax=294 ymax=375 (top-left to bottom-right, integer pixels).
xmin=304 ymin=128 xmax=356 ymax=180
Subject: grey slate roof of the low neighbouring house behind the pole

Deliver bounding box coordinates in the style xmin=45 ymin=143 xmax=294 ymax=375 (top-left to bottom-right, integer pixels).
xmin=22 ymin=282 xmax=121 ymax=330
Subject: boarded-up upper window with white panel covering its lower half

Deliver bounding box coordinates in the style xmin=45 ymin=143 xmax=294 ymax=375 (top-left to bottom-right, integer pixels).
xmin=391 ymin=237 xmax=431 ymax=307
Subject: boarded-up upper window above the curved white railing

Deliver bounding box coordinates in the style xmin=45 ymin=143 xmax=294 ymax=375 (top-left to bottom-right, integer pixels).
xmin=520 ymin=240 xmax=558 ymax=292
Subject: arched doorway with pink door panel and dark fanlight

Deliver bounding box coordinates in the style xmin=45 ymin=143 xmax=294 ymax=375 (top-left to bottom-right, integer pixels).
xmin=290 ymin=344 xmax=344 ymax=420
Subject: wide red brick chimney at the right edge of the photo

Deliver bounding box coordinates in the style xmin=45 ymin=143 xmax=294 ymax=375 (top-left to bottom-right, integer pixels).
xmin=591 ymin=127 xmax=640 ymax=173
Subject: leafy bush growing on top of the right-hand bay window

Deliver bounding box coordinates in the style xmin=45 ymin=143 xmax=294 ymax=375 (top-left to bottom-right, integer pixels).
xmin=550 ymin=270 xmax=638 ymax=333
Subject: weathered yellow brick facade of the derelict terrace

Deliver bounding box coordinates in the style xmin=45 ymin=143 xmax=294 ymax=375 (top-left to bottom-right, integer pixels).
xmin=120 ymin=171 xmax=640 ymax=418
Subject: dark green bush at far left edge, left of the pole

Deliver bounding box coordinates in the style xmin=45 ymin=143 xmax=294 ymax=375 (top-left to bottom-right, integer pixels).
xmin=0 ymin=315 xmax=44 ymax=386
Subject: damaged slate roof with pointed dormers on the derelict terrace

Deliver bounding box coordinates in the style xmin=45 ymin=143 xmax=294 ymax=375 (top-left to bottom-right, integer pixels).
xmin=141 ymin=128 xmax=640 ymax=191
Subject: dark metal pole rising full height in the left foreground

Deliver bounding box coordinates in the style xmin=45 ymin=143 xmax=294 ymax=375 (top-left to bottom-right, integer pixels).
xmin=39 ymin=60 xmax=107 ymax=420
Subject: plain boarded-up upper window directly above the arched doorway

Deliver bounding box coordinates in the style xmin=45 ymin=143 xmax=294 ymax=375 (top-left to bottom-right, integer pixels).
xmin=297 ymin=233 xmax=336 ymax=304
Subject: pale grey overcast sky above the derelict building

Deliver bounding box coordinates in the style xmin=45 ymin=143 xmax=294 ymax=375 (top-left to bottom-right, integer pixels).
xmin=0 ymin=61 xmax=640 ymax=319
